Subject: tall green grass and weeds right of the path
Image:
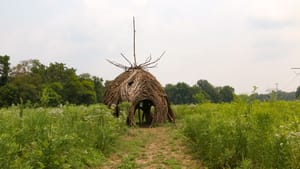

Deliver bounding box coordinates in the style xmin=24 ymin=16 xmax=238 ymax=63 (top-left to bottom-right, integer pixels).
xmin=175 ymin=101 xmax=300 ymax=169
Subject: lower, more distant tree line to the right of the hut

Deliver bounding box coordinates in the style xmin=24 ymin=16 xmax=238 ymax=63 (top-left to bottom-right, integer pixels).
xmin=165 ymin=80 xmax=300 ymax=104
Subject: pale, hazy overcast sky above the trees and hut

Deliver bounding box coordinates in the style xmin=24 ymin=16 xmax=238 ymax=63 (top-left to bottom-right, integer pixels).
xmin=0 ymin=0 xmax=300 ymax=94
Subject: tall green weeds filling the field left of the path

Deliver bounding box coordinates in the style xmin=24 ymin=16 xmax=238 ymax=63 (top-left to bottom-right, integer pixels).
xmin=0 ymin=105 xmax=124 ymax=168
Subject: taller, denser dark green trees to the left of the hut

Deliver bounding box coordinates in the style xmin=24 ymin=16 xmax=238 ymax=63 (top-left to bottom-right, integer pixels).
xmin=0 ymin=55 xmax=104 ymax=107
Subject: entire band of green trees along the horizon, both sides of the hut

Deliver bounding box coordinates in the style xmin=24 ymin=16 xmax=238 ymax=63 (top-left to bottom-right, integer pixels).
xmin=0 ymin=55 xmax=300 ymax=107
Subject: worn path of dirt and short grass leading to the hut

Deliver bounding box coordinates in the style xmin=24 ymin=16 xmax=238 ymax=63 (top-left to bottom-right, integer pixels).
xmin=100 ymin=125 xmax=204 ymax=169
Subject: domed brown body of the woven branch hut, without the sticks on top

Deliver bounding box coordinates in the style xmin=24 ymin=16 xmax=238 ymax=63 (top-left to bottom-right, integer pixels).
xmin=104 ymin=66 xmax=175 ymax=125
